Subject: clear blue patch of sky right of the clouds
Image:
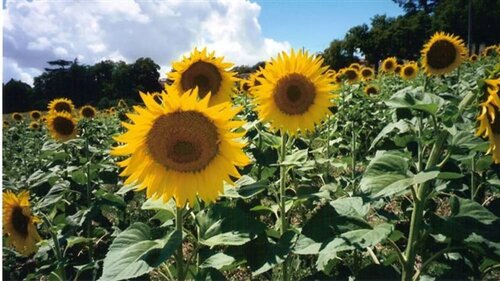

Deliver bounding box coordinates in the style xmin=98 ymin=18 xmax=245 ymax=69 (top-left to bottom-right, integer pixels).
xmin=256 ymin=0 xmax=403 ymax=52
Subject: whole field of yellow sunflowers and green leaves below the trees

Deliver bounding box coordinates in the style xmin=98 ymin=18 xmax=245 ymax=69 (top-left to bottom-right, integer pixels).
xmin=2 ymin=32 xmax=500 ymax=281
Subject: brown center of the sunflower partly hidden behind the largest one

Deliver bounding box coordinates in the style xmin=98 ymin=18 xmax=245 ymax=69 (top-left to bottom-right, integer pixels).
xmin=181 ymin=61 xmax=222 ymax=98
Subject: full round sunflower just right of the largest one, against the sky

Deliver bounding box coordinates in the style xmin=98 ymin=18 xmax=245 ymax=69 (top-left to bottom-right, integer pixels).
xmin=254 ymin=49 xmax=335 ymax=135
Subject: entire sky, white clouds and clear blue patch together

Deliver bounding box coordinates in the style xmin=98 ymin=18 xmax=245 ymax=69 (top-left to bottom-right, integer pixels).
xmin=3 ymin=0 xmax=402 ymax=84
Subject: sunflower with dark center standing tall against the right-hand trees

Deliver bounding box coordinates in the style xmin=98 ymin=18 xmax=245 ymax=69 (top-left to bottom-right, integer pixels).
xmin=422 ymin=32 xmax=467 ymax=75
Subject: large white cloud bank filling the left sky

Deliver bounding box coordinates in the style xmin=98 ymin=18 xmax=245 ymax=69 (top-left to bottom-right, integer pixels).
xmin=4 ymin=0 xmax=290 ymax=85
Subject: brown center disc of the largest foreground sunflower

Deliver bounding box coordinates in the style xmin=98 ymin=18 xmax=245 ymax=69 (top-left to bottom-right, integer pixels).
xmin=146 ymin=111 xmax=219 ymax=172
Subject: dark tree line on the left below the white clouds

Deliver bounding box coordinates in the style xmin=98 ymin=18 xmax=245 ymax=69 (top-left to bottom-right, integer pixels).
xmin=2 ymin=58 xmax=162 ymax=113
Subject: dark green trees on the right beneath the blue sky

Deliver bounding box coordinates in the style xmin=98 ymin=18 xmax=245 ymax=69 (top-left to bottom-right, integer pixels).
xmin=321 ymin=0 xmax=500 ymax=69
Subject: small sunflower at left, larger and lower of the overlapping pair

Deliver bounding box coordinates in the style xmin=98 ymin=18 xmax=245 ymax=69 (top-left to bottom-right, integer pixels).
xmin=47 ymin=111 xmax=77 ymax=142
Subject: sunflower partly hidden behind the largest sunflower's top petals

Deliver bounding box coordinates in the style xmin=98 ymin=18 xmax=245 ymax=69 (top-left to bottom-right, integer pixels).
xmin=168 ymin=48 xmax=237 ymax=105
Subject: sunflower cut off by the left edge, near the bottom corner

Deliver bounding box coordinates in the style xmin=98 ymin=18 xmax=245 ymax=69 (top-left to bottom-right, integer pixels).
xmin=3 ymin=191 xmax=41 ymax=256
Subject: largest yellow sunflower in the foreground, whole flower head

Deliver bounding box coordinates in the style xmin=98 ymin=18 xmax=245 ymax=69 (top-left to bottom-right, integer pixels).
xmin=111 ymin=88 xmax=250 ymax=207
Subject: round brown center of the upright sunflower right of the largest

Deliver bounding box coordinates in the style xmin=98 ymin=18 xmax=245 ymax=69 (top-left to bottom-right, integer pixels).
xmin=273 ymin=73 xmax=316 ymax=115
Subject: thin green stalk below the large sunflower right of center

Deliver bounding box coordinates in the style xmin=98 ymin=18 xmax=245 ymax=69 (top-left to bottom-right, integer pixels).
xmin=279 ymin=131 xmax=288 ymax=281
